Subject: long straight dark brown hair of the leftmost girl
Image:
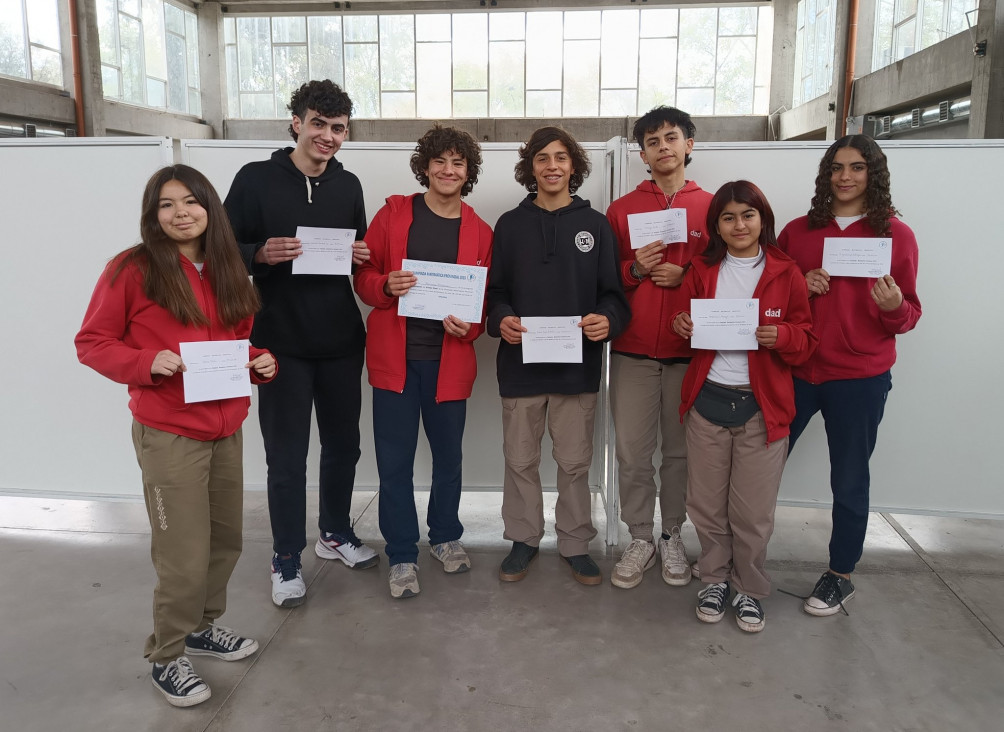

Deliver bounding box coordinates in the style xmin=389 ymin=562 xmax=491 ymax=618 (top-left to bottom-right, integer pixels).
xmin=111 ymin=165 xmax=260 ymax=326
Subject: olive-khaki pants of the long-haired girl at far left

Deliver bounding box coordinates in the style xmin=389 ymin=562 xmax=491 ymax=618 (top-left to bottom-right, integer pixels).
xmin=133 ymin=421 xmax=244 ymax=664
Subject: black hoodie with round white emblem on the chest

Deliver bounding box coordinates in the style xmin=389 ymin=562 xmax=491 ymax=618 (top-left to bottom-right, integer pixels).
xmin=487 ymin=194 xmax=631 ymax=397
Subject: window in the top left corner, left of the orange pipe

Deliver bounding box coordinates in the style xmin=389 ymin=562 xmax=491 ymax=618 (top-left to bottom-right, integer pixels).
xmin=0 ymin=0 xmax=63 ymax=87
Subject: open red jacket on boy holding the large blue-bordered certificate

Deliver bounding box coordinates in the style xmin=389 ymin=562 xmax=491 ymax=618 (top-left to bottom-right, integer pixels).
xmin=353 ymin=194 xmax=492 ymax=402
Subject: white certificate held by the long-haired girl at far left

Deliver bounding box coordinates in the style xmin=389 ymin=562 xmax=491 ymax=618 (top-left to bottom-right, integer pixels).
xmin=179 ymin=340 xmax=251 ymax=404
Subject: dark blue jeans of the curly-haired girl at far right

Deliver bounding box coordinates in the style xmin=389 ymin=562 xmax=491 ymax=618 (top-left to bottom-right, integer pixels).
xmin=788 ymin=372 xmax=893 ymax=574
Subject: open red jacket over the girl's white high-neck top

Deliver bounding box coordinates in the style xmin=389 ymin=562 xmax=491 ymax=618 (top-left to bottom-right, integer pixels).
xmin=673 ymin=247 xmax=818 ymax=443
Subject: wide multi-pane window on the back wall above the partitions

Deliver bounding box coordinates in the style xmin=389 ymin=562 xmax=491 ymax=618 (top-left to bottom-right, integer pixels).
xmin=224 ymin=5 xmax=771 ymax=118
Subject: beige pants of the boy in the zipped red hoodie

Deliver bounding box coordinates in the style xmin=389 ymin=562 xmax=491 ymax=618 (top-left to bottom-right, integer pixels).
xmin=610 ymin=353 xmax=687 ymax=542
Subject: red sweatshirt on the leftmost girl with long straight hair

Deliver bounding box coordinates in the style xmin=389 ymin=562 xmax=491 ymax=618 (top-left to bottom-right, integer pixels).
xmin=73 ymin=254 xmax=274 ymax=442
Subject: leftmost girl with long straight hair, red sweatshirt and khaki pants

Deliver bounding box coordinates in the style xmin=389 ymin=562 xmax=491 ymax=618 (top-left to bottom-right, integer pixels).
xmin=74 ymin=165 xmax=276 ymax=707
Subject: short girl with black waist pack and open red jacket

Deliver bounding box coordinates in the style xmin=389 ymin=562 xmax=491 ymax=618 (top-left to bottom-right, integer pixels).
xmin=673 ymin=181 xmax=816 ymax=633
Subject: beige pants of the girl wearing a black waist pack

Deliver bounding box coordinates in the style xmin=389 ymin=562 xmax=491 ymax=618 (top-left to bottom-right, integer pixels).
xmin=687 ymin=409 xmax=788 ymax=599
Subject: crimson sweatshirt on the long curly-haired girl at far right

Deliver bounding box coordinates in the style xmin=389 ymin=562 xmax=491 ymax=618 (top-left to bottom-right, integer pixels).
xmin=777 ymin=216 xmax=921 ymax=384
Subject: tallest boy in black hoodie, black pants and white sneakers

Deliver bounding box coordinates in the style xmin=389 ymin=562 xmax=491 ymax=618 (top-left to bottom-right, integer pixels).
xmin=225 ymin=79 xmax=380 ymax=607
